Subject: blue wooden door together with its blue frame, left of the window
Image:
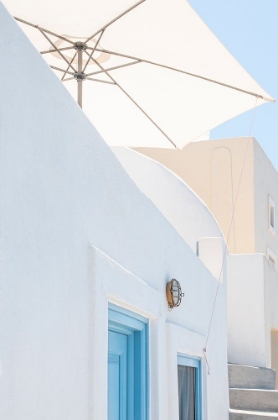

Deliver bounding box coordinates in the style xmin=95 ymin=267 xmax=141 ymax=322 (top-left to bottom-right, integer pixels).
xmin=108 ymin=304 xmax=148 ymax=420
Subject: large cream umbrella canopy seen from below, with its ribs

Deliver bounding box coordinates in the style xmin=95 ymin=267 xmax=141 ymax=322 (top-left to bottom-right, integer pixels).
xmin=4 ymin=0 xmax=273 ymax=148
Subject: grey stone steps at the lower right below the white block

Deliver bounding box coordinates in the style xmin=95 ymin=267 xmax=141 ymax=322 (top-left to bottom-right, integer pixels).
xmin=228 ymin=364 xmax=278 ymax=420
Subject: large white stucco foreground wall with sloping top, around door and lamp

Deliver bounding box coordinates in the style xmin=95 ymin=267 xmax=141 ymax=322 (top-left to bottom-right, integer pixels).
xmin=0 ymin=4 xmax=228 ymax=420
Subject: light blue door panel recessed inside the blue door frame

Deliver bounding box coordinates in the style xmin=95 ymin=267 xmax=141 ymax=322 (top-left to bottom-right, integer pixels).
xmin=108 ymin=331 xmax=127 ymax=420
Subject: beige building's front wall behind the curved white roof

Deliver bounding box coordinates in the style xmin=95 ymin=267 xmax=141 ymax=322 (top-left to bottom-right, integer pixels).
xmin=136 ymin=137 xmax=256 ymax=254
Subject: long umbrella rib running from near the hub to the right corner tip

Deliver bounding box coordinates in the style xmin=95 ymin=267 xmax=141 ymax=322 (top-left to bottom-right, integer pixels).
xmin=96 ymin=48 xmax=276 ymax=102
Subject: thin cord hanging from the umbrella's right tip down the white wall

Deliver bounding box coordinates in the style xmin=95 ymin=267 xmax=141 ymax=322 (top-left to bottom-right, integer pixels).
xmin=203 ymin=96 xmax=258 ymax=375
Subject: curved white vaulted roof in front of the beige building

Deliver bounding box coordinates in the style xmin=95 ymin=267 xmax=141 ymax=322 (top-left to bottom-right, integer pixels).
xmin=113 ymin=147 xmax=223 ymax=252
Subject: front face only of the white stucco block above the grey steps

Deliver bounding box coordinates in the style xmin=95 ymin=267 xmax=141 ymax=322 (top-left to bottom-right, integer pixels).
xmin=227 ymin=254 xmax=266 ymax=367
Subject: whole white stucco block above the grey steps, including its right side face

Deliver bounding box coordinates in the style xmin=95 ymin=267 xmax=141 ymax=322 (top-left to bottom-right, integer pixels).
xmin=227 ymin=254 xmax=278 ymax=368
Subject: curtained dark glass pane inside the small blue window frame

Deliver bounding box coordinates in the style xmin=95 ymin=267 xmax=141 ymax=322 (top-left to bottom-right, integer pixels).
xmin=178 ymin=365 xmax=196 ymax=420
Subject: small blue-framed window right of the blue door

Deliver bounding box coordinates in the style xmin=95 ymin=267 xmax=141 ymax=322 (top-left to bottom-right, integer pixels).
xmin=178 ymin=354 xmax=202 ymax=420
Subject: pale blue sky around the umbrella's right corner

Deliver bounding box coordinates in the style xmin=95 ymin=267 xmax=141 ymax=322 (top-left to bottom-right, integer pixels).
xmin=189 ymin=0 xmax=278 ymax=170
